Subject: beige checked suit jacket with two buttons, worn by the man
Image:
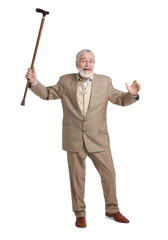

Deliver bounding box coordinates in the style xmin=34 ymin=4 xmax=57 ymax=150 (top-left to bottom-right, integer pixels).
xmin=31 ymin=73 xmax=139 ymax=152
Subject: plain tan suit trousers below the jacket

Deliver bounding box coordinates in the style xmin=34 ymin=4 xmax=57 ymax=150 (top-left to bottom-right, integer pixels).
xmin=67 ymin=144 xmax=119 ymax=217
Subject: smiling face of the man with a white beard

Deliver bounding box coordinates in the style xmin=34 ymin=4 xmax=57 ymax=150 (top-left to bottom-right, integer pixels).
xmin=76 ymin=52 xmax=94 ymax=78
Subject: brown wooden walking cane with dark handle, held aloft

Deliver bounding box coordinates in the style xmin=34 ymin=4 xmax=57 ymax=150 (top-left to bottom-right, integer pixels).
xmin=21 ymin=8 xmax=49 ymax=106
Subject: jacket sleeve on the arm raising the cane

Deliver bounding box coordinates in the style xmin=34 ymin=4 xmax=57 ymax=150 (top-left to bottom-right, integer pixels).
xmin=30 ymin=78 xmax=63 ymax=100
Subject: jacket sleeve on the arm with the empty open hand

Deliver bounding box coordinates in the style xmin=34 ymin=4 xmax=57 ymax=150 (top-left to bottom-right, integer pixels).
xmin=107 ymin=78 xmax=139 ymax=106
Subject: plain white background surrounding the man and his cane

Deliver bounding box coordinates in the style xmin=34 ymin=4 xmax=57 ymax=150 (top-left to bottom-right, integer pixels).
xmin=0 ymin=0 xmax=168 ymax=240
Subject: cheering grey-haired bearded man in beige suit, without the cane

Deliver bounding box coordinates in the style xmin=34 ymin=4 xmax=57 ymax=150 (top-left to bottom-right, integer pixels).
xmin=26 ymin=49 xmax=141 ymax=227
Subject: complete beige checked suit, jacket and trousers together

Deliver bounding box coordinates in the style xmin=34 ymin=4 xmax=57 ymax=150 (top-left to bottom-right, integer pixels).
xmin=31 ymin=74 xmax=139 ymax=217
